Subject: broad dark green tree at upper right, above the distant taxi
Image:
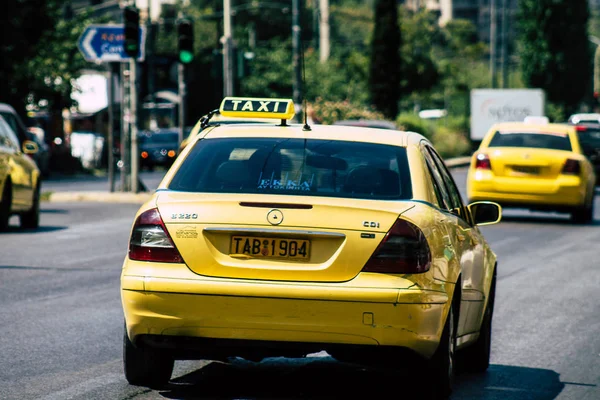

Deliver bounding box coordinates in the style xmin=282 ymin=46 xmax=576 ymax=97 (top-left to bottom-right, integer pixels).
xmin=518 ymin=0 xmax=592 ymax=116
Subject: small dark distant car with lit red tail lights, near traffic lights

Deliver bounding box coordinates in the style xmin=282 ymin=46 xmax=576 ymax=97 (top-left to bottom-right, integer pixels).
xmin=138 ymin=129 xmax=179 ymax=170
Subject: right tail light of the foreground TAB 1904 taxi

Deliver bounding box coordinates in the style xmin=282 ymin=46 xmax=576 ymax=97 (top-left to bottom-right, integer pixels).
xmin=362 ymin=219 xmax=431 ymax=274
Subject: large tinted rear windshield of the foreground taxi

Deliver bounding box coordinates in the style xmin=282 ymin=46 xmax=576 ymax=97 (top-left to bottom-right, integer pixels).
xmin=169 ymin=138 xmax=412 ymax=200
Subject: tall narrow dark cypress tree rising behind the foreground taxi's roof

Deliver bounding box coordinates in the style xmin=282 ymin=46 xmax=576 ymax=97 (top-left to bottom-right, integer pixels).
xmin=369 ymin=0 xmax=402 ymax=119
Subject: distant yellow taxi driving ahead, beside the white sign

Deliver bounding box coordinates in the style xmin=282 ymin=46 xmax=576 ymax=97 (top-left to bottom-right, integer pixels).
xmin=467 ymin=119 xmax=596 ymax=223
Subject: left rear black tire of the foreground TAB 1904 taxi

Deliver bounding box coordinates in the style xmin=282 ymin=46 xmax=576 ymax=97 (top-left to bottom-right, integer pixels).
xmin=123 ymin=329 xmax=175 ymax=389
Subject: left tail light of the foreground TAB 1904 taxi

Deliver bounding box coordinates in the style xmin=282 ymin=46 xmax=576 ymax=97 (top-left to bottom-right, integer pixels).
xmin=129 ymin=208 xmax=183 ymax=263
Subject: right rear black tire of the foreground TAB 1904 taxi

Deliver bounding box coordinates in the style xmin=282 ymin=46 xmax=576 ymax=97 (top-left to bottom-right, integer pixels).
xmin=429 ymin=306 xmax=456 ymax=399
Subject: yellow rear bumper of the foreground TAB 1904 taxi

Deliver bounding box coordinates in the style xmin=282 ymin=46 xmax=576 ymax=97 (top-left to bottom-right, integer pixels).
xmin=121 ymin=264 xmax=449 ymax=358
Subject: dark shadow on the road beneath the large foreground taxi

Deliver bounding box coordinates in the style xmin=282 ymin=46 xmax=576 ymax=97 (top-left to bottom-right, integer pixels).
xmin=152 ymin=357 xmax=564 ymax=400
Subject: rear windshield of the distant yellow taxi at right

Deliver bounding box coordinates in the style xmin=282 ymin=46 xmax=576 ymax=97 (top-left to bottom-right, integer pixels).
xmin=489 ymin=131 xmax=573 ymax=151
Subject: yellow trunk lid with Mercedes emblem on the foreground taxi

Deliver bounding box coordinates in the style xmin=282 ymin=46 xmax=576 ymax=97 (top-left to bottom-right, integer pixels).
xmin=157 ymin=192 xmax=413 ymax=282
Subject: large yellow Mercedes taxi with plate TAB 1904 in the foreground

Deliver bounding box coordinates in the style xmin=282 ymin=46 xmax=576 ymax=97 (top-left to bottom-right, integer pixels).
xmin=121 ymin=98 xmax=501 ymax=398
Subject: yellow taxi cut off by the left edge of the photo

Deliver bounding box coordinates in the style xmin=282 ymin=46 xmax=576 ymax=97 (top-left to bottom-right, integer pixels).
xmin=0 ymin=116 xmax=41 ymax=232
